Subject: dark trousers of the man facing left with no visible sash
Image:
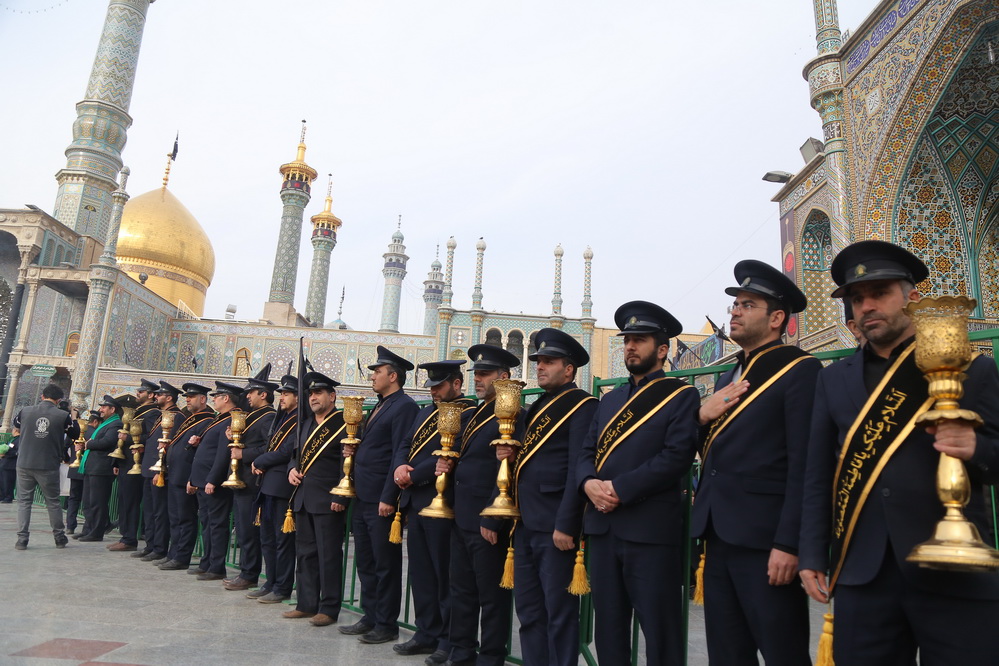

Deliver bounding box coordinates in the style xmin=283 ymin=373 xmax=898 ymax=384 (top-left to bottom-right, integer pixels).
xmin=351 ymin=499 xmax=402 ymax=631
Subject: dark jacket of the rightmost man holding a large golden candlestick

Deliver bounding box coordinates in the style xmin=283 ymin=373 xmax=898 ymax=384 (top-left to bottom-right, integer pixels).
xmin=799 ymin=342 xmax=999 ymax=599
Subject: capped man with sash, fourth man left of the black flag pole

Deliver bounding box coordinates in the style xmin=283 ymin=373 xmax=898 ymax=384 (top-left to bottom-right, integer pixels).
xmin=159 ymin=382 xmax=215 ymax=573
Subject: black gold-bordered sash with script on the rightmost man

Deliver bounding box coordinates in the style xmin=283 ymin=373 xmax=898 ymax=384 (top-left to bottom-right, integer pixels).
xmin=829 ymin=344 xmax=933 ymax=591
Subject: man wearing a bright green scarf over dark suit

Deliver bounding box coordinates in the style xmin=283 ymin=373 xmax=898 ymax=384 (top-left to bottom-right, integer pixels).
xmin=73 ymin=395 xmax=121 ymax=541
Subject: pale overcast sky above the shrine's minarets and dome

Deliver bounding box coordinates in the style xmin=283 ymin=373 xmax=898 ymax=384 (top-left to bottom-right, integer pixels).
xmin=0 ymin=0 xmax=876 ymax=333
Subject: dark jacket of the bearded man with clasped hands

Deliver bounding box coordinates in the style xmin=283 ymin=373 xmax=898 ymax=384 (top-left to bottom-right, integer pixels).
xmin=576 ymin=370 xmax=701 ymax=545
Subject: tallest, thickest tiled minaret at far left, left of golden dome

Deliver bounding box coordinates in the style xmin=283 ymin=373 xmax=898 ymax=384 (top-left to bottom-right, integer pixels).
xmin=54 ymin=0 xmax=151 ymax=241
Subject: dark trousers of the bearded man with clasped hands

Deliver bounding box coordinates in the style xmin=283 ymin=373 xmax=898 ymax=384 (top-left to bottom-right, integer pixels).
xmin=589 ymin=534 xmax=684 ymax=666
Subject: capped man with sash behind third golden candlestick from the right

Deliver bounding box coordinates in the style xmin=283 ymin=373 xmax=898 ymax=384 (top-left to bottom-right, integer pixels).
xmin=392 ymin=361 xmax=475 ymax=664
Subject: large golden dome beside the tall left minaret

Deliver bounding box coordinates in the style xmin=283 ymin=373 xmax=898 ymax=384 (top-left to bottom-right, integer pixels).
xmin=117 ymin=186 xmax=215 ymax=317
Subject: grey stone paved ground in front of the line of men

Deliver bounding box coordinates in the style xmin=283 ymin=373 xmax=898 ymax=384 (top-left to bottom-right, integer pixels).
xmin=0 ymin=504 xmax=821 ymax=666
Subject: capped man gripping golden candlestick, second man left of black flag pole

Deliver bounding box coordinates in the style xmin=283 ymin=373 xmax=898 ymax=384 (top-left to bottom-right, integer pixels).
xmin=217 ymin=370 xmax=278 ymax=590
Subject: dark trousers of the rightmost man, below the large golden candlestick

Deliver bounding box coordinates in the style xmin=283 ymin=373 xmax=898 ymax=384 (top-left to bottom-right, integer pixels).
xmin=833 ymin=548 xmax=999 ymax=666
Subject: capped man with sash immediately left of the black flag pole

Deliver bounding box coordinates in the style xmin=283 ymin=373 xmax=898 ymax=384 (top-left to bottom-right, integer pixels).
xmin=246 ymin=375 xmax=298 ymax=604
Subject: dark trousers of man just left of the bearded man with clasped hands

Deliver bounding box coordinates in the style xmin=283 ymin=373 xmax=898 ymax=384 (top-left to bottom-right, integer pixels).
xmin=513 ymin=525 xmax=579 ymax=666
